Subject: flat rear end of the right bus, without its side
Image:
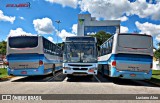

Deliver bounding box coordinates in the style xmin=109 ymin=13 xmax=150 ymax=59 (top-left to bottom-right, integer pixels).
xmin=110 ymin=34 xmax=153 ymax=80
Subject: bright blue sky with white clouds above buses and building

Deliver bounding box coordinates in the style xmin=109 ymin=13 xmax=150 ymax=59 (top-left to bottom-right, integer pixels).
xmin=0 ymin=0 xmax=160 ymax=47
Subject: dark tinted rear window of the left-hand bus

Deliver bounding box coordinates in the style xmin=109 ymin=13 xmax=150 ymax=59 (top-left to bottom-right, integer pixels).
xmin=9 ymin=36 xmax=38 ymax=48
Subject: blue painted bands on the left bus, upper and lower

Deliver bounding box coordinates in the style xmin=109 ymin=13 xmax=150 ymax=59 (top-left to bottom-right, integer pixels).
xmin=7 ymin=54 xmax=62 ymax=76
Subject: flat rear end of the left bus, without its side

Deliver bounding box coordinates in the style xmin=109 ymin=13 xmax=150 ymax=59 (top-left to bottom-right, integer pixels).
xmin=7 ymin=36 xmax=44 ymax=76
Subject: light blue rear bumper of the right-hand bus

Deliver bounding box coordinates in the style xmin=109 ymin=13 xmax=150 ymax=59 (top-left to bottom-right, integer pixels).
xmin=110 ymin=68 xmax=152 ymax=80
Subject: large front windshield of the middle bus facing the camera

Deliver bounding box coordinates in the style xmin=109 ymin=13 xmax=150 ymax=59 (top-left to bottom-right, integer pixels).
xmin=63 ymin=42 xmax=97 ymax=63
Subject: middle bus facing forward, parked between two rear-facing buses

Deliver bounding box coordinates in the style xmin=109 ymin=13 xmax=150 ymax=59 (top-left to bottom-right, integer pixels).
xmin=63 ymin=36 xmax=98 ymax=77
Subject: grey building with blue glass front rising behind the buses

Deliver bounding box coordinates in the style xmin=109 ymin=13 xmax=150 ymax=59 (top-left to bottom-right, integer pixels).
xmin=77 ymin=14 xmax=120 ymax=36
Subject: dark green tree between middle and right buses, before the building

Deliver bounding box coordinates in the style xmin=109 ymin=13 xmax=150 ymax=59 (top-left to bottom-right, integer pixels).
xmin=92 ymin=31 xmax=112 ymax=47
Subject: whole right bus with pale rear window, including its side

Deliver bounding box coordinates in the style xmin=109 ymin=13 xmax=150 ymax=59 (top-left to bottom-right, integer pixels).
xmin=98 ymin=33 xmax=153 ymax=80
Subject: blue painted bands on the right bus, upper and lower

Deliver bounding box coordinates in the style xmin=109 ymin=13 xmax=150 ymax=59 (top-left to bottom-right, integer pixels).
xmin=98 ymin=54 xmax=152 ymax=80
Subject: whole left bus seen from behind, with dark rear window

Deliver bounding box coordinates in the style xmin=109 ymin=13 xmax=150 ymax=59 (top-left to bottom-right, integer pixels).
xmin=6 ymin=36 xmax=62 ymax=76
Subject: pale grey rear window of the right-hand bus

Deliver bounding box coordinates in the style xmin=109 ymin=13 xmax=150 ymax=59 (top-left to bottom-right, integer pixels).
xmin=118 ymin=34 xmax=152 ymax=49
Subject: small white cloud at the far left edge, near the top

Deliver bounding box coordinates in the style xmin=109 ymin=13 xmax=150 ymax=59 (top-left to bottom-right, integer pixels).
xmin=0 ymin=10 xmax=16 ymax=24
